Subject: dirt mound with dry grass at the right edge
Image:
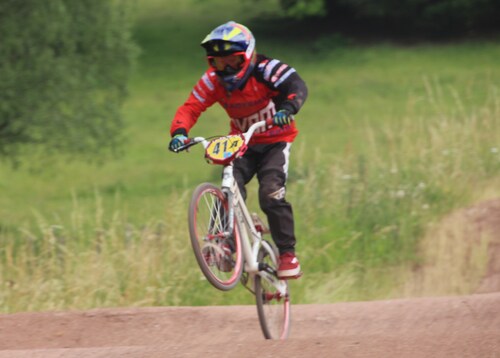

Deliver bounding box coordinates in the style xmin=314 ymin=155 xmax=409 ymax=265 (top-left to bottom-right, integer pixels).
xmin=400 ymin=199 xmax=500 ymax=297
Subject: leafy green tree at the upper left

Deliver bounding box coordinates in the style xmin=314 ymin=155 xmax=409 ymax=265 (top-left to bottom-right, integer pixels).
xmin=0 ymin=0 xmax=136 ymax=161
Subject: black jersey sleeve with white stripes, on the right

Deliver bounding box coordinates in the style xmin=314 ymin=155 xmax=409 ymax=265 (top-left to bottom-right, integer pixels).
xmin=256 ymin=56 xmax=308 ymax=114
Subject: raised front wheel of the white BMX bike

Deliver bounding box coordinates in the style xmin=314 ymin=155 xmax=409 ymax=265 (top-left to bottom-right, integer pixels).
xmin=188 ymin=183 xmax=243 ymax=291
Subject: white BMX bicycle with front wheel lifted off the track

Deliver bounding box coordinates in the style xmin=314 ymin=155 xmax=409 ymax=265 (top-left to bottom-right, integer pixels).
xmin=171 ymin=119 xmax=291 ymax=339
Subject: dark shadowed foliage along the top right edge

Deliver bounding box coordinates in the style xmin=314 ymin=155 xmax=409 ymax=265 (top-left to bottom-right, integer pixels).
xmin=280 ymin=0 xmax=500 ymax=35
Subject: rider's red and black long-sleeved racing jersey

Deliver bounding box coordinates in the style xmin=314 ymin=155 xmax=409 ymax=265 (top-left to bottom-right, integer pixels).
xmin=170 ymin=55 xmax=307 ymax=144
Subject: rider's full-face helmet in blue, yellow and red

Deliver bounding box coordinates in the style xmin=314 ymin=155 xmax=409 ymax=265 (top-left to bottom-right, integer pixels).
xmin=201 ymin=21 xmax=256 ymax=91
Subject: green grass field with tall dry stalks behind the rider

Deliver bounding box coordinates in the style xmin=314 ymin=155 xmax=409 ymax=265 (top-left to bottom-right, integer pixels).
xmin=0 ymin=0 xmax=500 ymax=312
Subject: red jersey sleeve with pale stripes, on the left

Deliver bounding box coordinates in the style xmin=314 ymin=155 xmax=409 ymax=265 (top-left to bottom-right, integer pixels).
xmin=170 ymin=71 xmax=218 ymax=136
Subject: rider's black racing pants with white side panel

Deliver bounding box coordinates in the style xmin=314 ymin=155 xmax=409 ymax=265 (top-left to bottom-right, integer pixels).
xmin=234 ymin=142 xmax=296 ymax=254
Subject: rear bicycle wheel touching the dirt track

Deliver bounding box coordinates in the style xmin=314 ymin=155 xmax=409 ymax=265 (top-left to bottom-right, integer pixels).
xmin=255 ymin=245 xmax=291 ymax=339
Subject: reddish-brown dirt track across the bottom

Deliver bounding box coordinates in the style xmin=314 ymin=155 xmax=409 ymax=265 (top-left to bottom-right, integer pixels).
xmin=0 ymin=293 xmax=500 ymax=358
